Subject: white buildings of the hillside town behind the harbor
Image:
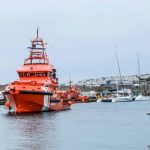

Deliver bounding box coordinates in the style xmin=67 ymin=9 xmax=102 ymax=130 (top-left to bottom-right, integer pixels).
xmin=60 ymin=74 xmax=150 ymax=95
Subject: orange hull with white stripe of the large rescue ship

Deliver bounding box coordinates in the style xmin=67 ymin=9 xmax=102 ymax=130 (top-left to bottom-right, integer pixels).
xmin=5 ymin=92 xmax=71 ymax=113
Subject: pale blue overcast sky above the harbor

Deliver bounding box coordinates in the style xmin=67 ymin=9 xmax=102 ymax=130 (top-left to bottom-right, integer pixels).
xmin=0 ymin=0 xmax=150 ymax=84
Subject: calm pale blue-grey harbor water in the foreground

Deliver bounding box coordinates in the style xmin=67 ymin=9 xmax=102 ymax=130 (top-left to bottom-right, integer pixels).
xmin=0 ymin=101 xmax=150 ymax=150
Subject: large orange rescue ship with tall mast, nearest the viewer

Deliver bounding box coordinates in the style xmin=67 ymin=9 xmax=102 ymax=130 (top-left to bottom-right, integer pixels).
xmin=4 ymin=30 xmax=72 ymax=113
